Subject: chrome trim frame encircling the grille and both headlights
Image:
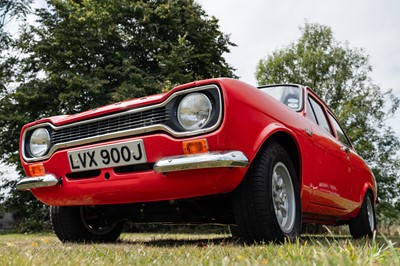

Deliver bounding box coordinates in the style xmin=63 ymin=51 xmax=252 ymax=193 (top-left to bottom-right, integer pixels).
xmin=21 ymin=84 xmax=222 ymax=162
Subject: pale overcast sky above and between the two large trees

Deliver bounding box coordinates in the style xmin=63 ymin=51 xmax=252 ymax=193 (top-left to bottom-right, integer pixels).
xmin=197 ymin=0 xmax=400 ymax=137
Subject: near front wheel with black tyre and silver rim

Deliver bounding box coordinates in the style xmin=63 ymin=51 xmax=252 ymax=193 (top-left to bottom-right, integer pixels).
xmin=233 ymin=142 xmax=301 ymax=243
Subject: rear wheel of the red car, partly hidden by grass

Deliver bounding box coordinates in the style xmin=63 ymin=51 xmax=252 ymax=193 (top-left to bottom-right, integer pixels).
xmin=349 ymin=191 xmax=376 ymax=239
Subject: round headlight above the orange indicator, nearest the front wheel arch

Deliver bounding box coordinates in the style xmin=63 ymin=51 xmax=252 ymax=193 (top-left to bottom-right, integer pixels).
xmin=178 ymin=93 xmax=212 ymax=131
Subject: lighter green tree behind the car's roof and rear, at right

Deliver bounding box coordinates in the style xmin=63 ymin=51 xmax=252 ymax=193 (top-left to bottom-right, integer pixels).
xmin=256 ymin=23 xmax=400 ymax=223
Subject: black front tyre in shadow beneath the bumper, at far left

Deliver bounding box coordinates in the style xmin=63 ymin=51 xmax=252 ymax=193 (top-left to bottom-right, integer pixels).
xmin=50 ymin=206 xmax=125 ymax=242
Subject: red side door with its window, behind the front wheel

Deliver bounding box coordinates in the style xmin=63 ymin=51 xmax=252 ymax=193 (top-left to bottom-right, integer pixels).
xmin=306 ymin=94 xmax=351 ymax=216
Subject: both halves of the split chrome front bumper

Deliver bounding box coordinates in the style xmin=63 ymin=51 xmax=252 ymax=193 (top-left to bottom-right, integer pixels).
xmin=17 ymin=151 xmax=249 ymax=190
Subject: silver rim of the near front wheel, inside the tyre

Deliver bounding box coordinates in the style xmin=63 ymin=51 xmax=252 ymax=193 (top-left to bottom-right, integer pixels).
xmin=272 ymin=162 xmax=296 ymax=233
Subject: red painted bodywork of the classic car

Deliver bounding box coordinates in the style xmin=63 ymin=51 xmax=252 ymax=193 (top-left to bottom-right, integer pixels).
xmin=21 ymin=79 xmax=376 ymax=222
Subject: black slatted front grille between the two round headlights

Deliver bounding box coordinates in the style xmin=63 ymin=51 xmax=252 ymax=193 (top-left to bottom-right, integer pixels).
xmin=52 ymin=107 xmax=169 ymax=145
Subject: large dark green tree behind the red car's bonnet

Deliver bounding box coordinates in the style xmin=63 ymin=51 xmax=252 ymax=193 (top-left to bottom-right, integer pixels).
xmin=0 ymin=0 xmax=234 ymax=231
